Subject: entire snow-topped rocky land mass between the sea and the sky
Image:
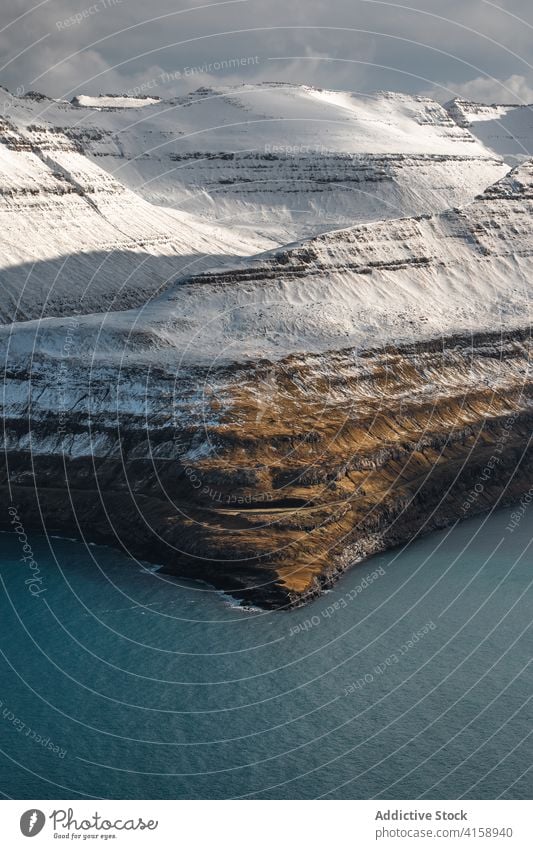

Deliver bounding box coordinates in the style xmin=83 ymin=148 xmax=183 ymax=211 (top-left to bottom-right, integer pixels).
xmin=0 ymin=86 xmax=533 ymax=607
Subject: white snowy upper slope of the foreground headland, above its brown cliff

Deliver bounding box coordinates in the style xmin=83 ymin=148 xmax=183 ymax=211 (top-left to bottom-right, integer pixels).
xmin=3 ymin=162 xmax=533 ymax=369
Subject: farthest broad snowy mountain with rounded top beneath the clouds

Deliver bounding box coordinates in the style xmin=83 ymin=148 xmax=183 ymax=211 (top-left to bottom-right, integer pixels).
xmin=5 ymin=83 xmax=506 ymax=244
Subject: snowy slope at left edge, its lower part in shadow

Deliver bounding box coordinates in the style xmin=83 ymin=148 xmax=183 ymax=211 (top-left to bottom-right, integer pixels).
xmin=0 ymin=114 xmax=268 ymax=321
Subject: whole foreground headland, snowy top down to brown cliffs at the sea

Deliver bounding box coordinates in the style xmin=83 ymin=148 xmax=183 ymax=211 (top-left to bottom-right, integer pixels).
xmin=0 ymin=163 xmax=533 ymax=607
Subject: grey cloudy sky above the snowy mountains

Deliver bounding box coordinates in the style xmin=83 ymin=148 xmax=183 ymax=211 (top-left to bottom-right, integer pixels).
xmin=0 ymin=0 xmax=533 ymax=103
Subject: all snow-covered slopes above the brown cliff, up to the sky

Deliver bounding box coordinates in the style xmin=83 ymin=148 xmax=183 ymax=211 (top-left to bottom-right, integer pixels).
xmin=4 ymin=84 xmax=533 ymax=369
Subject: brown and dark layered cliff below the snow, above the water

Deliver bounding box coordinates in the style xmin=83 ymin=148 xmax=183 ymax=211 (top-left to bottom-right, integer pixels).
xmin=1 ymin=331 xmax=533 ymax=608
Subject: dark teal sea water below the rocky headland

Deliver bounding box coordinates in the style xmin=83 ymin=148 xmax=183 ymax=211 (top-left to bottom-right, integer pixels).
xmin=0 ymin=506 xmax=533 ymax=799
